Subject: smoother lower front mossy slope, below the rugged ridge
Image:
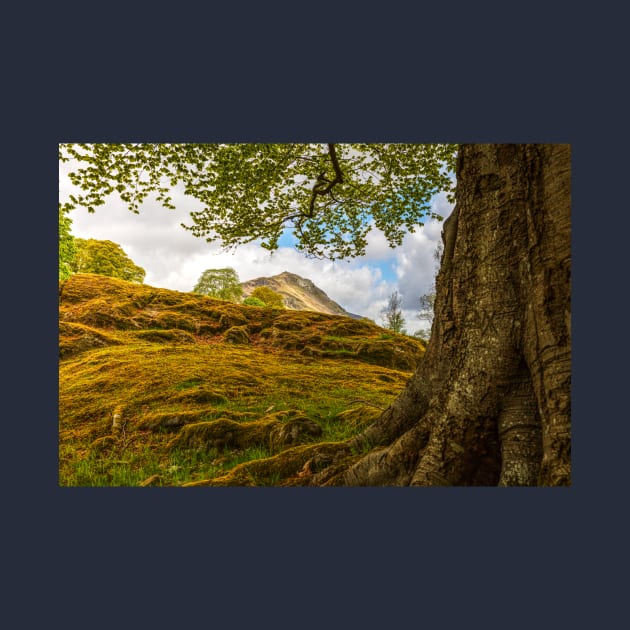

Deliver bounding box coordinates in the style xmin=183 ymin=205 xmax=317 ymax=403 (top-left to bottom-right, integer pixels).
xmin=59 ymin=343 xmax=408 ymax=485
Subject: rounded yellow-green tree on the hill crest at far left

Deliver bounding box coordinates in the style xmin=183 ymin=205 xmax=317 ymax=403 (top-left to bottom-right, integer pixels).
xmin=72 ymin=238 xmax=146 ymax=283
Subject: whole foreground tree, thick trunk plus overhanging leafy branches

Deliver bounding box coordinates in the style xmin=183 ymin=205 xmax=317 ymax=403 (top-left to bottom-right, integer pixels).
xmin=60 ymin=144 xmax=571 ymax=486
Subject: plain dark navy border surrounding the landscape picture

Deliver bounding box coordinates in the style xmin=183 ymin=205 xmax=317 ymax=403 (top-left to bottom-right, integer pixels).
xmin=3 ymin=2 xmax=628 ymax=629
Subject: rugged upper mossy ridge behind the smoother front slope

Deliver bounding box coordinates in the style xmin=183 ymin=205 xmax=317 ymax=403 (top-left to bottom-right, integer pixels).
xmin=59 ymin=274 xmax=424 ymax=371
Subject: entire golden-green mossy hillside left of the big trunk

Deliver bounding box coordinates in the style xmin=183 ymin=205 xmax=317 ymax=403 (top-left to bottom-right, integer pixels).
xmin=59 ymin=274 xmax=422 ymax=486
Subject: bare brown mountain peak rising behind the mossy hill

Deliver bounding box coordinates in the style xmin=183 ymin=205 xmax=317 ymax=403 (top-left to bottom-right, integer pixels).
xmin=241 ymin=271 xmax=361 ymax=319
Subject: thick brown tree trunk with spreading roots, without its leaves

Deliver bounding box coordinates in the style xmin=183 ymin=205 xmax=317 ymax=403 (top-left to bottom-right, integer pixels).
xmin=310 ymin=145 xmax=571 ymax=486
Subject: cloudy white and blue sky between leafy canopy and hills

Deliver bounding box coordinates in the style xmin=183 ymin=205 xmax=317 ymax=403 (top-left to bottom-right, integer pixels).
xmin=59 ymin=156 xmax=452 ymax=333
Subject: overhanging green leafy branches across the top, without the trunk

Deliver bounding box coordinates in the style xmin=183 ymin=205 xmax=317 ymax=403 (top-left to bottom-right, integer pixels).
xmin=59 ymin=144 xmax=456 ymax=259
